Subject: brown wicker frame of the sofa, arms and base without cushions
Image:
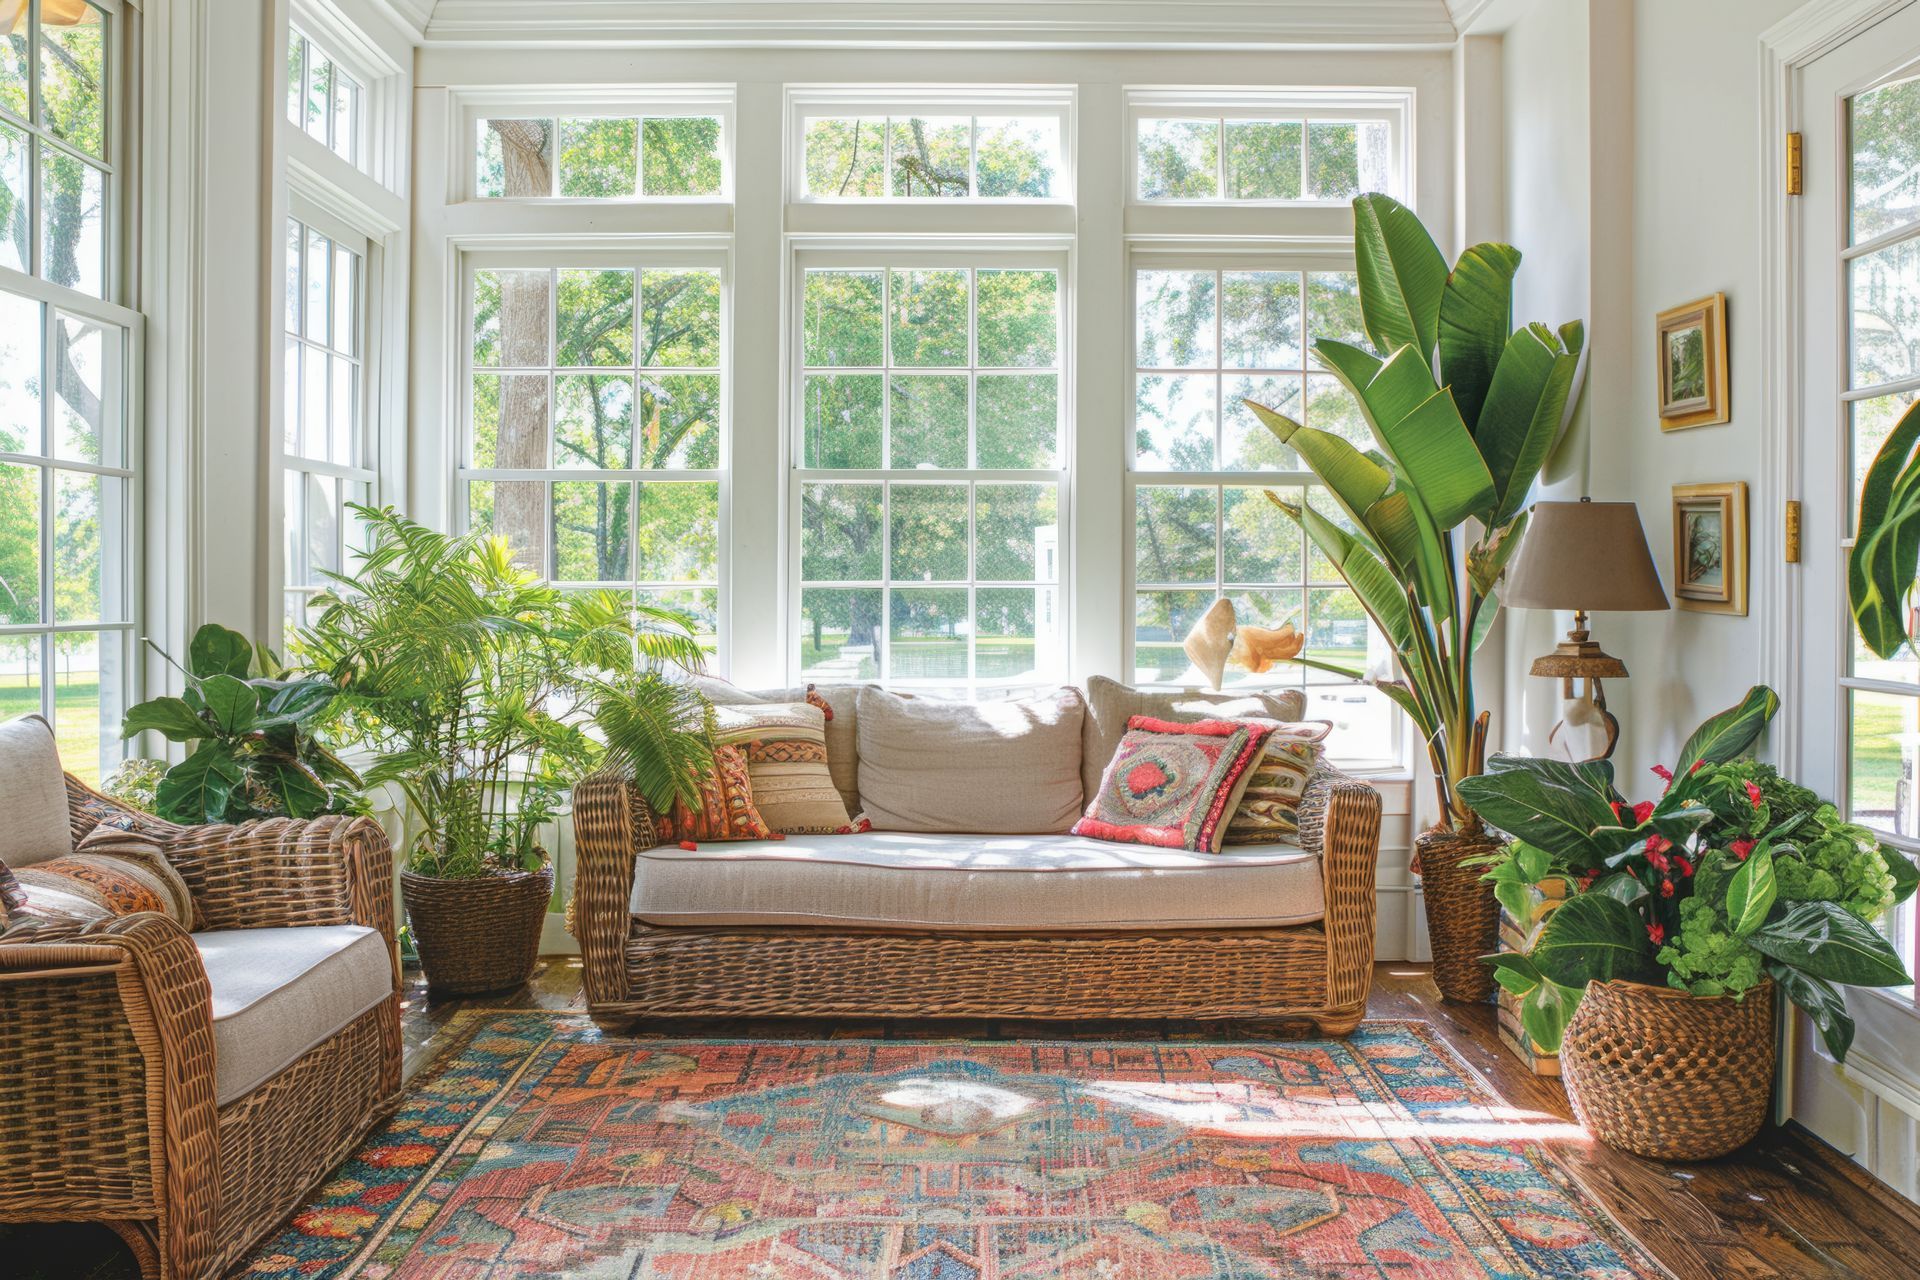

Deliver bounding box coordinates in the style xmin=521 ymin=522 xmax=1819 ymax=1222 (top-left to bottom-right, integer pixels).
xmin=574 ymin=770 xmax=1380 ymax=1034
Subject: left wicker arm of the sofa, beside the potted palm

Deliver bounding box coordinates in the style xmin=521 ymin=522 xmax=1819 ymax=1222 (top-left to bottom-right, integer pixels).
xmin=574 ymin=770 xmax=655 ymax=1007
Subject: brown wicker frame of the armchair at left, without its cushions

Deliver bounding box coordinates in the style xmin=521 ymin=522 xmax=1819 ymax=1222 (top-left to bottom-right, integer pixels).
xmin=0 ymin=775 xmax=401 ymax=1280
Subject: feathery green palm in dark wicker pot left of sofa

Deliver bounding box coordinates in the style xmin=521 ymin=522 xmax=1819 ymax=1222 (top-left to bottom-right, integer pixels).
xmin=296 ymin=507 xmax=701 ymax=994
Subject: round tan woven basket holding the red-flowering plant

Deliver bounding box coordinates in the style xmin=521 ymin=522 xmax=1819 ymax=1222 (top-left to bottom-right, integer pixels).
xmin=1561 ymin=981 xmax=1776 ymax=1159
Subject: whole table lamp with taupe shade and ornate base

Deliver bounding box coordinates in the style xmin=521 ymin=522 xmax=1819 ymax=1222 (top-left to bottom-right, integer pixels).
xmin=1500 ymin=497 xmax=1667 ymax=760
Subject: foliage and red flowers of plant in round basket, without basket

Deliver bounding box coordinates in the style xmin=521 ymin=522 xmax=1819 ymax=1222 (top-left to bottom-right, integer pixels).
xmin=1461 ymin=685 xmax=1920 ymax=1059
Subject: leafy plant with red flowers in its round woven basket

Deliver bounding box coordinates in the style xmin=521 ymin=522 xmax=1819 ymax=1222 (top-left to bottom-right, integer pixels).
xmin=1461 ymin=687 xmax=1920 ymax=1159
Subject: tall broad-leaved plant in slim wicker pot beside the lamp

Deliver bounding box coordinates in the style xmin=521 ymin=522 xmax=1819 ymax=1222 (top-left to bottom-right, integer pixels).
xmin=1248 ymin=194 xmax=1584 ymax=1000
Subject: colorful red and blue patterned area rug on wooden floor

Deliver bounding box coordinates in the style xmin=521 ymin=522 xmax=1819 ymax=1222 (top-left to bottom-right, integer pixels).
xmin=244 ymin=1011 xmax=1665 ymax=1280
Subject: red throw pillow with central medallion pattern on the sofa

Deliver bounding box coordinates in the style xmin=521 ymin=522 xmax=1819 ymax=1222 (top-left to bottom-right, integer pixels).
xmin=1073 ymin=716 xmax=1273 ymax=852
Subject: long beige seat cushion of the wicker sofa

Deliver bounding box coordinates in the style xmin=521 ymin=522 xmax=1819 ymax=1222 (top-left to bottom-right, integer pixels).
xmin=632 ymin=831 xmax=1325 ymax=933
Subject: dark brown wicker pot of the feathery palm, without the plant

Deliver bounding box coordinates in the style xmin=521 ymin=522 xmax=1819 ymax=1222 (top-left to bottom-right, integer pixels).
xmin=399 ymin=867 xmax=553 ymax=996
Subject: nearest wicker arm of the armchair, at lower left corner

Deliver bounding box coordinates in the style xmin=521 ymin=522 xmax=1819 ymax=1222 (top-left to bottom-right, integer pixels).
xmin=0 ymin=913 xmax=221 ymax=1276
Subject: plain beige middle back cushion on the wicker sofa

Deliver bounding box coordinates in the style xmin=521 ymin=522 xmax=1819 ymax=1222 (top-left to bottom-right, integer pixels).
xmin=858 ymin=689 xmax=1087 ymax=835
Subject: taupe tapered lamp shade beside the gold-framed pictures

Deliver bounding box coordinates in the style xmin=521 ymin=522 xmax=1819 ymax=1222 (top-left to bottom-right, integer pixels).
xmin=1500 ymin=497 xmax=1667 ymax=614
